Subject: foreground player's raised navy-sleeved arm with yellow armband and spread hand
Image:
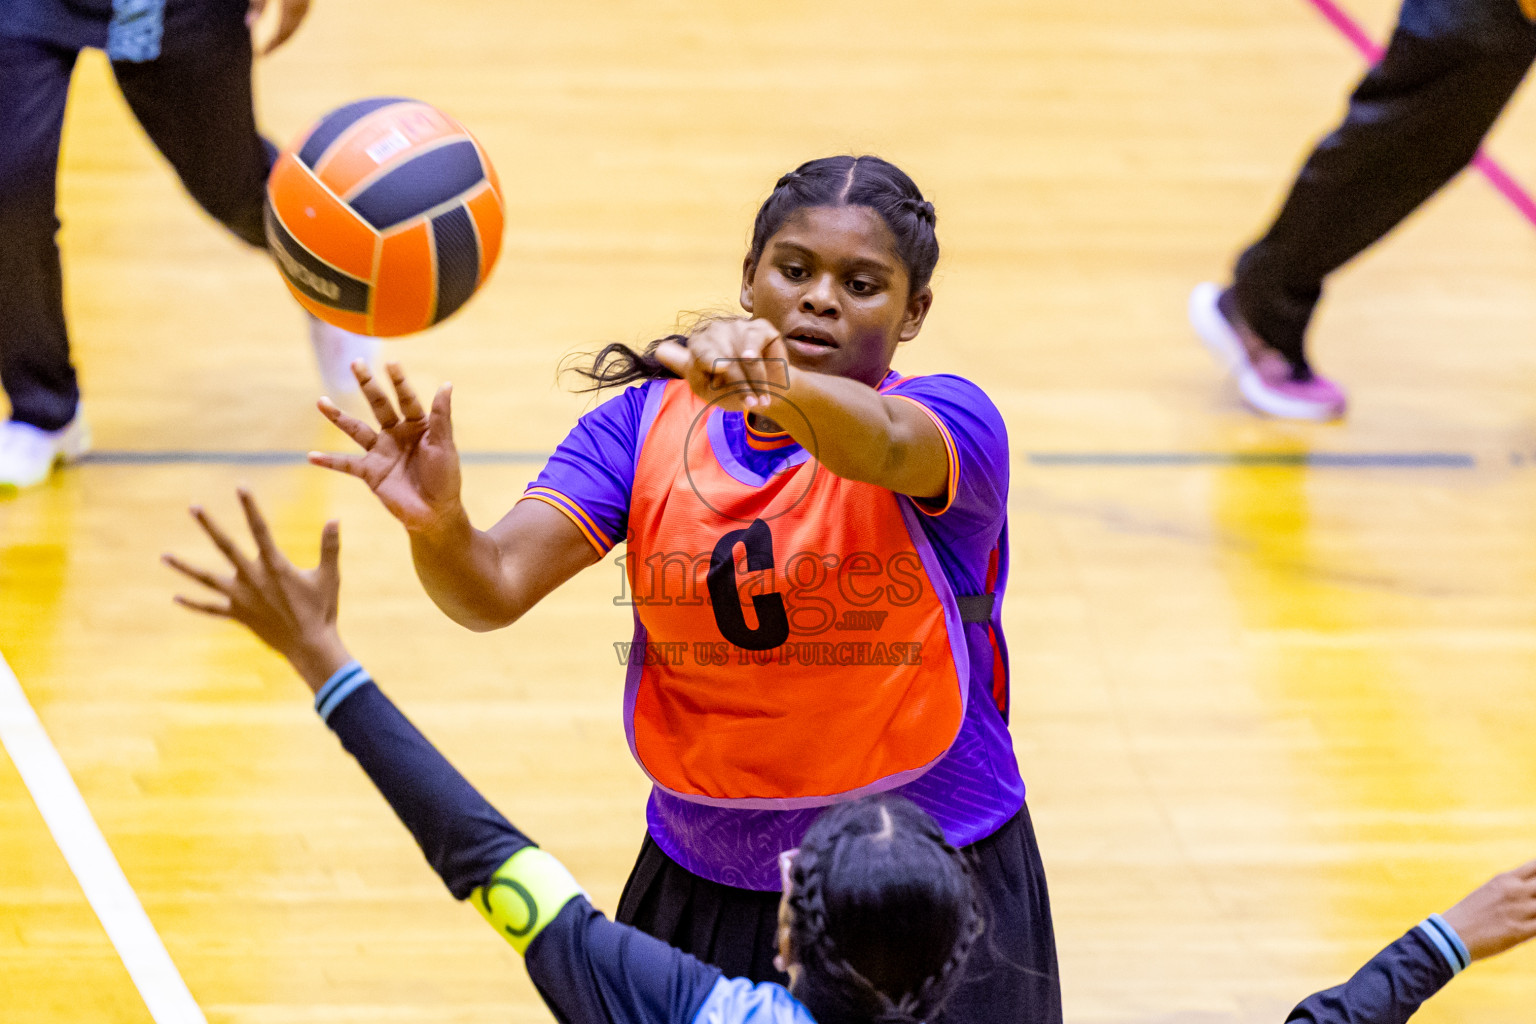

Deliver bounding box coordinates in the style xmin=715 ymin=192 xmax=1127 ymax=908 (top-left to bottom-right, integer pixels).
xmin=164 ymin=490 xmax=720 ymax=1024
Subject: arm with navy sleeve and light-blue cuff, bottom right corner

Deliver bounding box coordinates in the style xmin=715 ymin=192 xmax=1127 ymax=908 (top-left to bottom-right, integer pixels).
xmin=1286 ymin=861 xmax=1536 ymax=1024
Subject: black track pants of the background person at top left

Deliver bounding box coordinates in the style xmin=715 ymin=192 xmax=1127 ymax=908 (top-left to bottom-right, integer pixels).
xmin=0 ymin=0 xmax=276 ymax=430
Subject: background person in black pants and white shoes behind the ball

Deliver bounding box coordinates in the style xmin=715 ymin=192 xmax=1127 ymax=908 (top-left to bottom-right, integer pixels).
xmin=0 ymin=0 xmax=376 ymax=488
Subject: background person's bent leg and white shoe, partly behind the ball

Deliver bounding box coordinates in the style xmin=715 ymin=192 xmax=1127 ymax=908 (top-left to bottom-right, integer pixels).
xmin=112 ymin=3 xmax=376 ymax=396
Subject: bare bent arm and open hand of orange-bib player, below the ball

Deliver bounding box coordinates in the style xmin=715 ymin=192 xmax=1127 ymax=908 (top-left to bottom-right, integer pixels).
xmin=309 ymin=362 xmax=598 ymax=631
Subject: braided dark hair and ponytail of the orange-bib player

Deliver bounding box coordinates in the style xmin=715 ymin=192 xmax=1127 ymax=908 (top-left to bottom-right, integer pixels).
xmin=568 ymin=157 xmax=938 ymax=391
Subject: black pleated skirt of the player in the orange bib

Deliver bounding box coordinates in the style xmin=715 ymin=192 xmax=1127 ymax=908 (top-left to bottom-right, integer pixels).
xmin=616 ymin=806 xmax=1061 ymax=1024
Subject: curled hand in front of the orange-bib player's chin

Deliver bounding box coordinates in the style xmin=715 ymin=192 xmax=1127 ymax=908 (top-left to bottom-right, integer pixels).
xmin=656 ymin=318 xmax=790 ymax=415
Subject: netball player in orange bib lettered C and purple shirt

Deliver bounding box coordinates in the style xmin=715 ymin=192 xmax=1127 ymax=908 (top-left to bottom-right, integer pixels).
xmin=312 ymin=157 xmax=1061 ymax=1024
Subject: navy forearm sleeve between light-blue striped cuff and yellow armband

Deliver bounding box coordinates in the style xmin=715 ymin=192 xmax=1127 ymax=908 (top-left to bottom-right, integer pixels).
xmin=315 ymin=662 xmax=533 ymax=900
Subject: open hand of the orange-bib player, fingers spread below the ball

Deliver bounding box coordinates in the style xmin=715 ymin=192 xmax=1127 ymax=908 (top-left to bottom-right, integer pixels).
xmin=309 ymin=361 xmax=464 ymax=533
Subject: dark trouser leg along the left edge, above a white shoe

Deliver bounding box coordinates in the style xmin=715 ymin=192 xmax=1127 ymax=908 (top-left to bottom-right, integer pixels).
xmin=0 ymin=37 xmax=80 ymax=430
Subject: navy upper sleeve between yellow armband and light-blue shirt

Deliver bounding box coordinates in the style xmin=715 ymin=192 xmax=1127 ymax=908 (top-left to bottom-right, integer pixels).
xmin=525 ymin=897 xmax=720 ymax=1024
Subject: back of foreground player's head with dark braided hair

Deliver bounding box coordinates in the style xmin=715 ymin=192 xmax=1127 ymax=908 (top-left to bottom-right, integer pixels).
xmin=779 ymin=795 xmax=982 ymax=1024
